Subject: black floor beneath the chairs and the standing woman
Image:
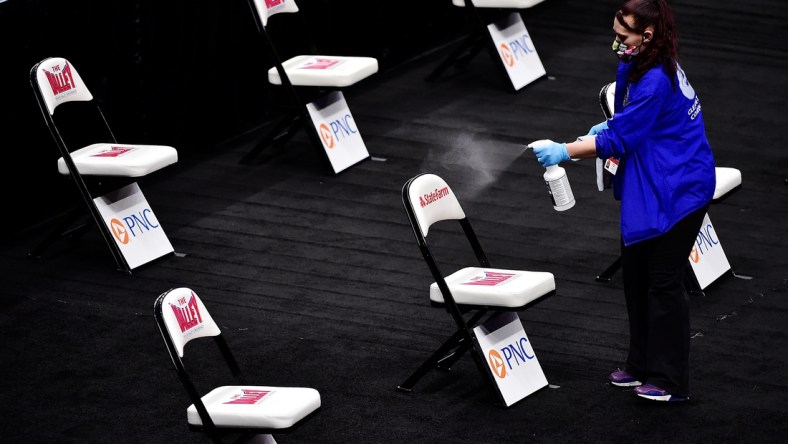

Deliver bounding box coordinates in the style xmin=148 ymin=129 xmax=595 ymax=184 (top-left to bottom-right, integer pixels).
xmin=0 ymin=0 xmax=788 ymax=443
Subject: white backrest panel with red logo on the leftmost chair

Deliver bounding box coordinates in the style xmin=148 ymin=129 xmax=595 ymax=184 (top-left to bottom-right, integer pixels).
xmin=36 ymin=57 xmax=93 ymax=116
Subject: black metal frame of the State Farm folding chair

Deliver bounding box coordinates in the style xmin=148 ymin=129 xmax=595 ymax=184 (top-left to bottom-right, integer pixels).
xmin=397 ymin=174 xmax=555 ymax=404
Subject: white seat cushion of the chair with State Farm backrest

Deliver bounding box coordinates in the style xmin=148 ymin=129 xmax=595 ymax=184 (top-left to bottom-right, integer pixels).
xmin=430 ymin=267 xmax=555 ymax=308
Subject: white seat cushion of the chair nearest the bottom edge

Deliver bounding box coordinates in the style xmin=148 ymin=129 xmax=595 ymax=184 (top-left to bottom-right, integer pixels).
xmin=186 ymin=386 xmax=320 ymax=429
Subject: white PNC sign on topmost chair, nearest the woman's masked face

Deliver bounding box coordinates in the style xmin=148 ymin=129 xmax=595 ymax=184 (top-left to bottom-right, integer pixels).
xmin=487 ymin=12 xmax=547 ymax=90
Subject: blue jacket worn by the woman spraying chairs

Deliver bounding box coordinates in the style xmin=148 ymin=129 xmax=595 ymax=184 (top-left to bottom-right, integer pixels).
xmin=596 ymin=62 xmax=716 ymax=245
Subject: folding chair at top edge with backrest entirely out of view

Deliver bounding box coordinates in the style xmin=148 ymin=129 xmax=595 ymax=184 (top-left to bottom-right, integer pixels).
xmin=426 ymin=0 xmax=546 ymax=92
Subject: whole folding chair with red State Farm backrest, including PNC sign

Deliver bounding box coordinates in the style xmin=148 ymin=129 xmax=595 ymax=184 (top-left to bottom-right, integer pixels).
xmin=397 ymin=174 xmax=555 ymax=406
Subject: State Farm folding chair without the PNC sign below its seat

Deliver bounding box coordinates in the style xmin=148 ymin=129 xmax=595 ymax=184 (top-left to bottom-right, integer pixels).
xmin=397 ymin=173 xmax=555 ymax=405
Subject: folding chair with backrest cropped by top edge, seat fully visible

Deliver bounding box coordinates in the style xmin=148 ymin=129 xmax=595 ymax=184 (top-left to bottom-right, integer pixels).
xmin=241 ymin=0 xmax=378 ymax=174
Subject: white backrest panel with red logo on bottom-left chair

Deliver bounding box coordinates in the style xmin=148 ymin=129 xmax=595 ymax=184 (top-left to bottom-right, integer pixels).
xmin=161 ymin=287 xmax=221 ymax=358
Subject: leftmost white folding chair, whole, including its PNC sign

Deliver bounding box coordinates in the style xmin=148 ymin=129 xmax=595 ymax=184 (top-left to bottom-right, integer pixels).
xmin=30 ymin=57 xmax=178 ymax=273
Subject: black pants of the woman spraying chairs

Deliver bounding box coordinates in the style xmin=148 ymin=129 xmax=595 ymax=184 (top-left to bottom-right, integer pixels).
xmin=621 ymin=205 xmax=708 ymax=396
